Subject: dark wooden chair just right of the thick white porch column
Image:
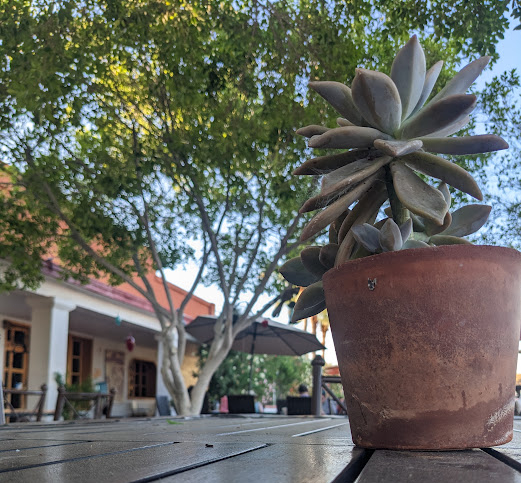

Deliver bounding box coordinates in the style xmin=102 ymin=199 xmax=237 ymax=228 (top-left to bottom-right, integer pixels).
xmin=54 ymin=386 xmax=116 ymax=421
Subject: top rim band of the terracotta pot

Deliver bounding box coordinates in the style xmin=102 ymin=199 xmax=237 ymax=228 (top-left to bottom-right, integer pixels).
xmin=323 ymin=244 xmax=521 ymax=280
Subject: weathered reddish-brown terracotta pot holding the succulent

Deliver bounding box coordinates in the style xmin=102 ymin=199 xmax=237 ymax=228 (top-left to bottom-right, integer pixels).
xmin=324 ymin=245 xmax=521 ymax=449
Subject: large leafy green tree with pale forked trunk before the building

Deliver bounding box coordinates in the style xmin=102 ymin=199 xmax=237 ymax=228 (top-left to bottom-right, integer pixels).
xmin=0 ymin=0 xmax=508 ymax=414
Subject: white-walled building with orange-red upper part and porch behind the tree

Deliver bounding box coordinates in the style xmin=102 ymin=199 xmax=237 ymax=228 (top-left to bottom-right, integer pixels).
xmin=0 ymin=260 xmax=215 ymax=416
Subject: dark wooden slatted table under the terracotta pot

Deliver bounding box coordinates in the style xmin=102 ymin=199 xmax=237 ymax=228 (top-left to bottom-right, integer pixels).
xmin=0 ymin=415 xmax=521 ymax=483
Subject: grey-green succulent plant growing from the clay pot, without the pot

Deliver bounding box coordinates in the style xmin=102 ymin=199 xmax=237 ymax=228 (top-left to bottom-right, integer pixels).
xmin=280 ymin=36 xmax=508 ymax=322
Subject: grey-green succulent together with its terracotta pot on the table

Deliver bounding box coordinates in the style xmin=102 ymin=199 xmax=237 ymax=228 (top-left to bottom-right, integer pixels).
xmin=281 ymin=36 xmax=521 ymax=449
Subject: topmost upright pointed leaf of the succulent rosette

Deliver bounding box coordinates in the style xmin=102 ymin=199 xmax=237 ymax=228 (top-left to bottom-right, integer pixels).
xmin=391 ymin=35 xmax=426 ymax=119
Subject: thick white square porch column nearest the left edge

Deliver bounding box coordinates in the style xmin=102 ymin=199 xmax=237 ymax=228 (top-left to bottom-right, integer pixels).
xmin=27 ymin=297 xmax=76 ymax=411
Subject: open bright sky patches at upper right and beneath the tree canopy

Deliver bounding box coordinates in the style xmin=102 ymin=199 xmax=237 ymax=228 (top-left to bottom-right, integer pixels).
xmin=167 ymin=14 xmax=521 ymax=366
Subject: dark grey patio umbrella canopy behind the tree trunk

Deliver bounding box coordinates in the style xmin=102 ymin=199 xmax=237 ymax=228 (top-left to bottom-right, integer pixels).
xmin=186 ymin=315 xmax=325 ymax=356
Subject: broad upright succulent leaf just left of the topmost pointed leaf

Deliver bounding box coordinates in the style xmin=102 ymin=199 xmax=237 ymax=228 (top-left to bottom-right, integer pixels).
xmin=351 ymin=69 xmax=402 ymax=134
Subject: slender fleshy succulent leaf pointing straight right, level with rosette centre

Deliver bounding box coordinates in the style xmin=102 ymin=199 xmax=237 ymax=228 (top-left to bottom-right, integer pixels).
xmin=422 ymin=134 xmax=508 ymax=154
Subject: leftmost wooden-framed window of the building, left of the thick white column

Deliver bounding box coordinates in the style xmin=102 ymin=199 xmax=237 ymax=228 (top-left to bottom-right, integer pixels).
xmin=4 ymin=320 xmax=30 ymax=409
